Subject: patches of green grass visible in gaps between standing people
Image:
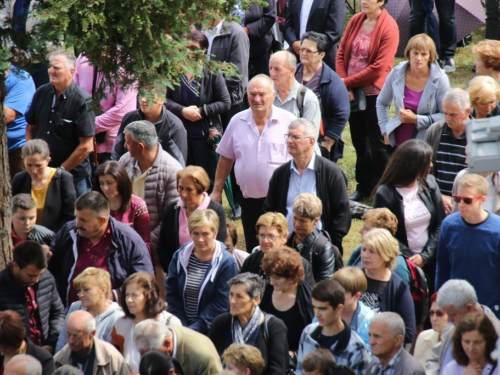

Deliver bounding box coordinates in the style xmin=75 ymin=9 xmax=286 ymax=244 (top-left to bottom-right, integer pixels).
xmin=224 ymin=26 xmax=484 ymax=260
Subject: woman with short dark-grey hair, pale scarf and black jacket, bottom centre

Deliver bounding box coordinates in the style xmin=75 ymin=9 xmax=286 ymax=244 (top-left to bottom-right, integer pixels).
xmin=208 ymin=272 xmax=289 ymax=375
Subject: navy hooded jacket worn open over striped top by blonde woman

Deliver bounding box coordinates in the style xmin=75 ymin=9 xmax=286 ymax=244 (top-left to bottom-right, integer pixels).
xmin=165 ymin=241 xmax=238 ymax=335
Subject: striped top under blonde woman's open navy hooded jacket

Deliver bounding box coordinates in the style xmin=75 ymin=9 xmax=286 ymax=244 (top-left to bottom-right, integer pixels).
xmin=184 ymin=253 xmax=212 ymax=324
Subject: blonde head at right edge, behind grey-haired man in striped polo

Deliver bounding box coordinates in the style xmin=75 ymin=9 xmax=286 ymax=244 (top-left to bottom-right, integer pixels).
xmin=466 ymin=76 xmax=500 ymax=119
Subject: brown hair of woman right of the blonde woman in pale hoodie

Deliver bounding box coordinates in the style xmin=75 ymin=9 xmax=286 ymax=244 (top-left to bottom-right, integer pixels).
xmin=119 ymin=272 xmax=165 ymax=319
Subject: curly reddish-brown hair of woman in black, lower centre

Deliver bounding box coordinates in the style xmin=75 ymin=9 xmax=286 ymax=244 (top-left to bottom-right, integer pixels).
xmin=262 ymin=246 xmax=304 ymax=284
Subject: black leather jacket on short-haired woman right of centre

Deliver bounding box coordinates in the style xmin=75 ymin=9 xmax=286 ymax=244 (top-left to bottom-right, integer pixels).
xmin=286 ymin=229 xmax=343 ymax=282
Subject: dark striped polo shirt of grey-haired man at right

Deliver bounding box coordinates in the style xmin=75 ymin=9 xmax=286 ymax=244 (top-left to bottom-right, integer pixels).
xmin=436 ymin=125 xmax=467 ymax=196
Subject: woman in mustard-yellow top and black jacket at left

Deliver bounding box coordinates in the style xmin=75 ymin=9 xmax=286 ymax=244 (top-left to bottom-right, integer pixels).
xmin=12 ymin=139 xmax=76 ymax=233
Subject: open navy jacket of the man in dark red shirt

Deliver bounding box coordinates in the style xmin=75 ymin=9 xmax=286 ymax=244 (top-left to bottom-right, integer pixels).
xmin=49 ymin=217 xmax=154 ymax=307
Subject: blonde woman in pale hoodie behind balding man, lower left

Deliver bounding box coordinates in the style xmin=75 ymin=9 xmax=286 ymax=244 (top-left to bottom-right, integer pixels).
xmin=56 ymin=267 xmax=123 ymax=353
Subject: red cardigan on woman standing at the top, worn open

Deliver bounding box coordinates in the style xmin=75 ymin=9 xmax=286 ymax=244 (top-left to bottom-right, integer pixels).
xmin=336 ymin=9 xmax=399 ymax=89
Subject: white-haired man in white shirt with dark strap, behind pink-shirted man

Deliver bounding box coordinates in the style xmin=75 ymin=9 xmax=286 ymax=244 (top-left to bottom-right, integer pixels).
xmin=269 ymin=51 xmax=321 ymax=134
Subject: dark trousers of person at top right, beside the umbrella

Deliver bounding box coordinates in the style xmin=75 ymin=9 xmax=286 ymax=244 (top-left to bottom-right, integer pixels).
xmin=409 ymin=0 xmax=457 ymax=60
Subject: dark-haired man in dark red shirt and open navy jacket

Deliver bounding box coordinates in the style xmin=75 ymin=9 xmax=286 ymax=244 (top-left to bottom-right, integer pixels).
xmin=49 ymin=191 xmax=154 ymax=306
